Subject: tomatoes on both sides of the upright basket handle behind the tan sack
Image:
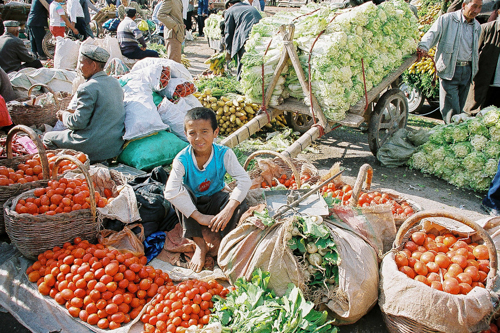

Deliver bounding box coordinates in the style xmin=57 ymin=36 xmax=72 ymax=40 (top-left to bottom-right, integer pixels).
xmin=320 ymin=182 xmax=414 ymax=218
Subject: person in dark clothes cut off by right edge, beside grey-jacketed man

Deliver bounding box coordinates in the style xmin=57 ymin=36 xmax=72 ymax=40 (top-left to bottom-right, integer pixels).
xmin=464 ymin=11 xmax=500 ymax=113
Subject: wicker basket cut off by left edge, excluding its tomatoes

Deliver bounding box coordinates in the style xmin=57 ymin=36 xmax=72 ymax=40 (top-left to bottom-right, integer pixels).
xmin=0 ymin=125 xmax=49 ymax=234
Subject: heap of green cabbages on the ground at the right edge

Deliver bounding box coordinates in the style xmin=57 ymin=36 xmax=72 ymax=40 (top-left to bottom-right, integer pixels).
xmin=409 ymin=106 xmax=500 ymax=192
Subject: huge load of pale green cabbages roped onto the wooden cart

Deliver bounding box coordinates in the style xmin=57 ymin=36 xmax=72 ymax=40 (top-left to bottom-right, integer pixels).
xmin=241 ymin=0 xmax=419 ymax=121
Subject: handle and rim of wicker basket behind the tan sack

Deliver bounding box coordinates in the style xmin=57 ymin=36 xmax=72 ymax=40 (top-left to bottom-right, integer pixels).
xmin=349 ymin=164 xmax=422 ymax=226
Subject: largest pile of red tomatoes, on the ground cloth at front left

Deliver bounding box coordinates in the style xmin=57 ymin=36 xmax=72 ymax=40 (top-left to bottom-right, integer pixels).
xmin=26 ymin=238 xmax=173 ymax=329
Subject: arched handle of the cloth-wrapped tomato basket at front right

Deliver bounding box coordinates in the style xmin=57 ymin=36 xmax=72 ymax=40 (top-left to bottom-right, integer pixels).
xmin=393 ymin=210 xmax=498 ymax=290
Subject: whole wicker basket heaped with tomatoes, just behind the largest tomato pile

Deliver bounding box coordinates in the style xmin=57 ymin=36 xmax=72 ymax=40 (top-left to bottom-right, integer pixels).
xmin=4 ymin=156 xmax=100 ymax=259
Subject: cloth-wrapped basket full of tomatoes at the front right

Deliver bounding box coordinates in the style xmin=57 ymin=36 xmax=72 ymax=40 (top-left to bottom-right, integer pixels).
xmin=379 ymin=211 xmax=498 ymax=332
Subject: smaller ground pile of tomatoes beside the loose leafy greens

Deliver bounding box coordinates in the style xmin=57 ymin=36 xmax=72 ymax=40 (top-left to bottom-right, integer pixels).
xmin=141 ymin=280 xmax=229 ymax=333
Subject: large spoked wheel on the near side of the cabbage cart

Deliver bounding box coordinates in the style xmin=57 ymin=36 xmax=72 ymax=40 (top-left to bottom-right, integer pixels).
xmin=368 ymin=89 xmax=408 ymax=156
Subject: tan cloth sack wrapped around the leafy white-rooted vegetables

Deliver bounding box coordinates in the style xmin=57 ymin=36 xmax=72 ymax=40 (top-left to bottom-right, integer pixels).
xmin=218 ymin=206 xmax=378 ymax=324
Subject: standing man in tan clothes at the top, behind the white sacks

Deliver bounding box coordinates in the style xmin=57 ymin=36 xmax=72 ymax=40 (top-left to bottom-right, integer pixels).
xmin=158 ymin=0 xmax=184 ymax=63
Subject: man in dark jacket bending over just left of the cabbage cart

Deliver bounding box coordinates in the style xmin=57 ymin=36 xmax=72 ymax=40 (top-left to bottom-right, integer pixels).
xmin=224 ymin=0 xmax=262 ymax=80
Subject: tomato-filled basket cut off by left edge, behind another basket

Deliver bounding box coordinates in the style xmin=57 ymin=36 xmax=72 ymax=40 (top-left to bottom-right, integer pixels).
xmin=0 ymin=125 xmax=90 ymax=234
